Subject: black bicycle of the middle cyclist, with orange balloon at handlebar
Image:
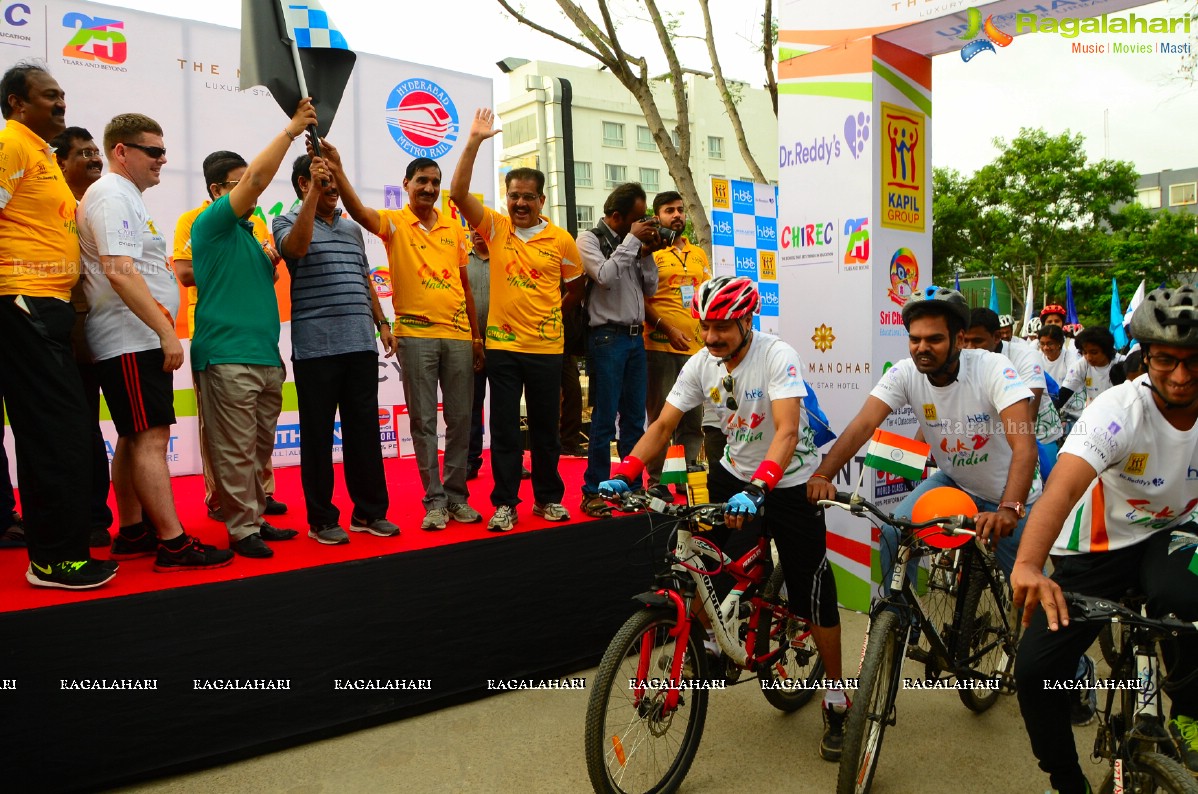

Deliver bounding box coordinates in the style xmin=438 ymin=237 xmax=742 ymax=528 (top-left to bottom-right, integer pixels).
xmin=819 ymin=492 xmax=1021 ymax=794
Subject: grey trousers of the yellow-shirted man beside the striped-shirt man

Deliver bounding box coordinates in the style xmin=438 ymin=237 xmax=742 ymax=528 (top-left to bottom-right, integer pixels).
xmin=397 ymin=337 xmax=474 ymax=510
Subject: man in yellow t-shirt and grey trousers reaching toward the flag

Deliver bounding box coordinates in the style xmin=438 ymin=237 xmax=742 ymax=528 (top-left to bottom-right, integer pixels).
xmin=321 ymin=147 xmax=484 ymax=531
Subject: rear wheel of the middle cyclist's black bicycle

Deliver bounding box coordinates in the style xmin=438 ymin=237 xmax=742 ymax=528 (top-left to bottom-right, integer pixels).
xmin=952 ymin=551 xmax=1014 ymax=714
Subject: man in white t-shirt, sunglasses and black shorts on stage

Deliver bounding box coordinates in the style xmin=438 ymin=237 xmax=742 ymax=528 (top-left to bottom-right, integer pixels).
xmin=75 ymin=114 xmax=232 ymax=572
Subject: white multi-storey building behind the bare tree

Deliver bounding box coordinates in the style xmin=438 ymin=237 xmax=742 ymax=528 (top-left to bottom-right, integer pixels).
xmin=498 ymin=59 xmax=778 ymax=234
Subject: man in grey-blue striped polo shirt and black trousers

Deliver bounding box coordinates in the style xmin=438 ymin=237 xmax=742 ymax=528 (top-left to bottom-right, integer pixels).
xmin=274 ymin=154 xmax=399 ymax=545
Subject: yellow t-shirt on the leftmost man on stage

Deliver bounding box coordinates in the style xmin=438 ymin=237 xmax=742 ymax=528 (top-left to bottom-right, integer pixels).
xmin=0 ymin=119 xmax=79 ymax=301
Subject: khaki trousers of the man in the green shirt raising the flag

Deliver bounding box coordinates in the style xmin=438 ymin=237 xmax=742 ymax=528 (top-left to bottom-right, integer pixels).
xmin=195 ymin=364 xmax=285 ymax=540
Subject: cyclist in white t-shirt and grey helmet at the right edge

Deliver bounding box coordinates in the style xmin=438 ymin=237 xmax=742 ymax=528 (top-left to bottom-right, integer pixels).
xmin=1011 ymin=286 xmax=1198 ymax=794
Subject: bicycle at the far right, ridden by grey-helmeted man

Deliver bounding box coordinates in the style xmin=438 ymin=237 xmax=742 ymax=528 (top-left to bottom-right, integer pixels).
xmin=1064 ymin=593 xmax=1198 ymax=794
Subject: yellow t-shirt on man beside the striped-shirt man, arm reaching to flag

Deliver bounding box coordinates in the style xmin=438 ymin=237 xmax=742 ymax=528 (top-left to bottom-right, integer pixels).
xmin=379 ymin=206 xmax=471 ymax=341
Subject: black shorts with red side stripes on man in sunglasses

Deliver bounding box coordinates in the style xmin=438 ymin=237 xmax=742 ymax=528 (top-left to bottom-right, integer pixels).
xmin=96 ymin=348 xmax=175 ymax=436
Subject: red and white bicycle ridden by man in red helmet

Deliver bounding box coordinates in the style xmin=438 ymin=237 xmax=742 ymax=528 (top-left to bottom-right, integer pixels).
xmin=583 ymin=493 xmax=823 ymax=794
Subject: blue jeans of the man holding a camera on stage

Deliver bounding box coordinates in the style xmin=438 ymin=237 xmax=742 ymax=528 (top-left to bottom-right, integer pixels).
xmin=582 ymin=326 xmax=648 ymax=495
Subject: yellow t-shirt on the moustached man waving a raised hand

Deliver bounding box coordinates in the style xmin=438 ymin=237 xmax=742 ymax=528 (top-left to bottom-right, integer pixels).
xmin=478 ymin=207 xmax=582 ymax=353
